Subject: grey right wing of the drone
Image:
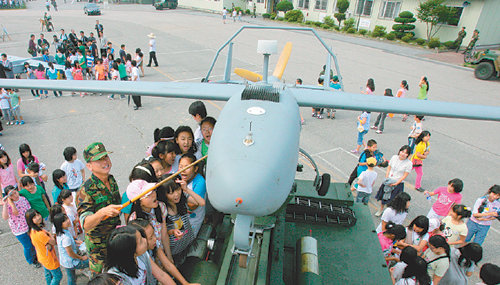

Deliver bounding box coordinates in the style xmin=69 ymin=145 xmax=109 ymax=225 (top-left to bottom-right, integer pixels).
xmin=289 ymin=87 xmax=500 ymax=121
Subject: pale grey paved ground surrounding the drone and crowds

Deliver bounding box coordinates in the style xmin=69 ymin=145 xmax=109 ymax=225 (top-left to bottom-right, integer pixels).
xmin=0 ymin=1 xmax=500 ymax=284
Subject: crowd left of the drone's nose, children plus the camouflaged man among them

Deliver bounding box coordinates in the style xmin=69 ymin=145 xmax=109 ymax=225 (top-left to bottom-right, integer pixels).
xmin=0 ymin=101 xmax=216 ymax=284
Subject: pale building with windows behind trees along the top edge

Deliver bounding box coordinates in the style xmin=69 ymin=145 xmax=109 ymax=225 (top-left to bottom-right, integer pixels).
xmin=179 ymin=0 xmax=500 ymax=46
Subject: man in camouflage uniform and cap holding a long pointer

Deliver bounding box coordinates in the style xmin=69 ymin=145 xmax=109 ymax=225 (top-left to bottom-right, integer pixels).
xmin=77 ymin=142 xmax=121 ymax=275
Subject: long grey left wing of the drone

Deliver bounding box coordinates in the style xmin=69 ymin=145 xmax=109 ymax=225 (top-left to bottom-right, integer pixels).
xmin=0 ymin=79 xmax=245 ymax=101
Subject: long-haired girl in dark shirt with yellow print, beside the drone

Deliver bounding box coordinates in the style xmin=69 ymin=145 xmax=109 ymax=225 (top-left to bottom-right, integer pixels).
xmin=158 ymin=177 xmax=196 ymax=266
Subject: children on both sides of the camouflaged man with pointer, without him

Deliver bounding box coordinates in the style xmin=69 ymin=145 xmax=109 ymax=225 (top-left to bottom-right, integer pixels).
xmin=0 ymin=101 xmax=216 ymax=284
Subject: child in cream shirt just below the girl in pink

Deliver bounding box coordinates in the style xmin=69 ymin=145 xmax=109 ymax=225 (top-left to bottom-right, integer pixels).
xmin=441 ymin=205 xmax=472 ymax=248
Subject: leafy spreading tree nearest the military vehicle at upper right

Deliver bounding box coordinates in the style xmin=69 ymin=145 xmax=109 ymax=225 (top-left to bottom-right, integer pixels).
xmin=417 ymin=0 xmax=453 ymax=41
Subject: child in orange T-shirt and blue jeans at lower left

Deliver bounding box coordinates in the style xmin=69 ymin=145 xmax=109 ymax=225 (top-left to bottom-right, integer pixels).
xmin=25 ymin=207 xmax=62 ymax=285
